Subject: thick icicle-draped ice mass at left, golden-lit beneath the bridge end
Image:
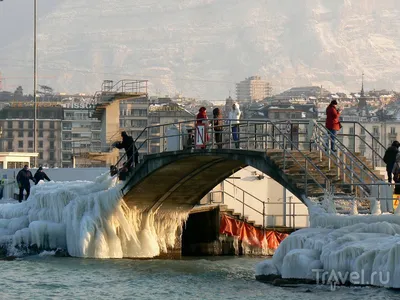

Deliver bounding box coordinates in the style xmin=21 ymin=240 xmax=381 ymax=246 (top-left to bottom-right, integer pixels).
xmin=0 ymin=173 xmax=188 ymax=258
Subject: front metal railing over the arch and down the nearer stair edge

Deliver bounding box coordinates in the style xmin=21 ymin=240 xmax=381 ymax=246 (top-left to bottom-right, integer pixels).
xmin=117 ymin=119 xmax=331 ymax=196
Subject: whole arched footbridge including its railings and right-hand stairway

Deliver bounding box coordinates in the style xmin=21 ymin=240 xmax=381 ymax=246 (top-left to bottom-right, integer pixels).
xmin=118 ymin=120 xmax=382 ymax=210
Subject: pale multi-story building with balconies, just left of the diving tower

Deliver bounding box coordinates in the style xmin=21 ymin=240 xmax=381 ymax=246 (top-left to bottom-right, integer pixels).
xmin=61 ymin=103 xmax=102 ymax=168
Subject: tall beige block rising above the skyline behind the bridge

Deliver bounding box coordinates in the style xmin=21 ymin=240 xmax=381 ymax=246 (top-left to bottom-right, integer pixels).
xmin=236 ymin=76 xmax=272 ymax=101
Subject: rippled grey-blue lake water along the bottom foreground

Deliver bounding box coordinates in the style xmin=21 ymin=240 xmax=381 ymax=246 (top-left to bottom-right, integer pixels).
xmin=0 ymin=255 xmax=400 ymax=300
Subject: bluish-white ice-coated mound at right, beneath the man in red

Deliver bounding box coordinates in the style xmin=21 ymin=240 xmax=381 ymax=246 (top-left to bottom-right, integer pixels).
xmin=256 ymin=200 xmax=400 ymax=288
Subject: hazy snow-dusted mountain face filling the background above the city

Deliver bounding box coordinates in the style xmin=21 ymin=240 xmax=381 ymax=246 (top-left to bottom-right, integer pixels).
xmin=0 ymin=0 xmax=400 ymax=99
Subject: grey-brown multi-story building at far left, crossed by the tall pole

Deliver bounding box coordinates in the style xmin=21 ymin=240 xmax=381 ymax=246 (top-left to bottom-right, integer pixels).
xmin=0 ymin=102 xmax=63 ymax=167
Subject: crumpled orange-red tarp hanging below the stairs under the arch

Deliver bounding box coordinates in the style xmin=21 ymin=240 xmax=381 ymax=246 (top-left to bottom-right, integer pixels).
xmin=219 ymin=215 xmax=288 ymax=250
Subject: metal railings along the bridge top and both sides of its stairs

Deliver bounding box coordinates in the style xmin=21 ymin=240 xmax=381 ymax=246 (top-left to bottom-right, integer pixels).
xmin=106 ymin=119 xmax=388 ymax=205
